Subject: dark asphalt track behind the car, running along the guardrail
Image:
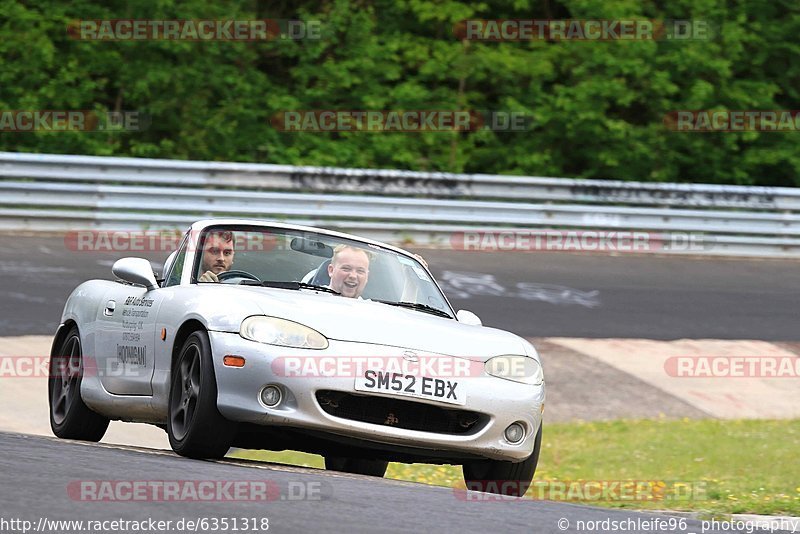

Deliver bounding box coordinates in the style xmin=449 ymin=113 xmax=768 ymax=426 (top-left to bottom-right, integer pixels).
xmin=0 ymin=235 xmax=800 ymax=341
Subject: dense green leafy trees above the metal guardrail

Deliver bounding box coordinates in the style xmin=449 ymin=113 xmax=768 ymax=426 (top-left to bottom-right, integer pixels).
xmin=0 ymin=0 xmax=800 ymax=186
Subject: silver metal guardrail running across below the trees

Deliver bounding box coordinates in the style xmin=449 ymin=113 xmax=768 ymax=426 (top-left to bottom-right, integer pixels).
xmin=0 ymin=152 xmax=800 ymax=257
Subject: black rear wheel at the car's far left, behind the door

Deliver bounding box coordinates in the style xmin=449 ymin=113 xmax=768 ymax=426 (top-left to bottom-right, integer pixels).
xmin=47 ymin=326 xmax=109 ymax=441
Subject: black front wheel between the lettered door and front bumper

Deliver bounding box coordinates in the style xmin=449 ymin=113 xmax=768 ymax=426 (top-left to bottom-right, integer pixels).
xmin=167 ymin=330 xmax=236 ymax=458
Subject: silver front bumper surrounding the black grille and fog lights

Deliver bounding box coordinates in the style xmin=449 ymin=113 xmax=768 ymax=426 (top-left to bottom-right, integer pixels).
xmin=209 ymin=331 xmax=545 ymax=461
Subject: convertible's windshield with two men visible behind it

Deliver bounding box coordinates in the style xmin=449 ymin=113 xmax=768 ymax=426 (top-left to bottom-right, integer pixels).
xmin=192 ymin=225 xmax=453 ymax=318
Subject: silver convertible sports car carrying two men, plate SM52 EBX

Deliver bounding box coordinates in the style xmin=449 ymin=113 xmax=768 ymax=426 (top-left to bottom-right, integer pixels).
xmin=48 ymin=219 xmax=545 ymax=495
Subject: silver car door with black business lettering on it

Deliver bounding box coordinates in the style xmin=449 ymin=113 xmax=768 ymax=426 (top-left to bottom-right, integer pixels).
xmin=95 ymin=283 xmax=164 ymax=395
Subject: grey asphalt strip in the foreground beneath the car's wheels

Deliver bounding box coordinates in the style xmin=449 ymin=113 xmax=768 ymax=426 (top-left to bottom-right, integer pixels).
xmin=0 ymin=433 xmax=752 ymax=534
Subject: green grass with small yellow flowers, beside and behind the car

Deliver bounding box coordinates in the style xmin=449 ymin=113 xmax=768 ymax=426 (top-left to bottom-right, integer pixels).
xmin=230 ymin=419 xmax=800 ymax=516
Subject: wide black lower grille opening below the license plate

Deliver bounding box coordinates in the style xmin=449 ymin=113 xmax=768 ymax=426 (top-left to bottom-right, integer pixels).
xmin=317 ymin=390 xmax=489 ymax=434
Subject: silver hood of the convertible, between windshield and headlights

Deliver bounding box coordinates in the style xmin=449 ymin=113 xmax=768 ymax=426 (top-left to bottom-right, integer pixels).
xmin=227 ymin=287 xmax=525 ymax=361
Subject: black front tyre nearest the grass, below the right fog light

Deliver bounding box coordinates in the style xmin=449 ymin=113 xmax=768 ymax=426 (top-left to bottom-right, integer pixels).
xmin=463 ymin=426 xmax=542 ymax=497
